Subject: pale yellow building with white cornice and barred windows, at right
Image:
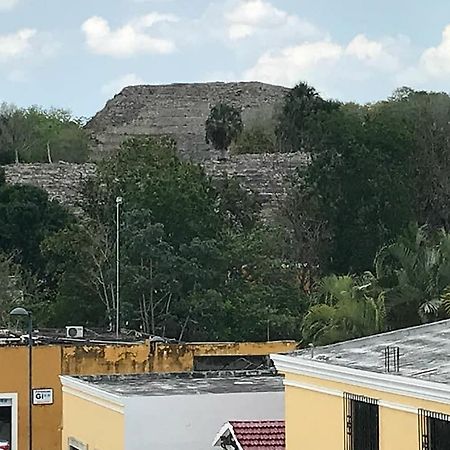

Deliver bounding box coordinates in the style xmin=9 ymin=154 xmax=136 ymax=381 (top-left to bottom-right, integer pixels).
xmin=272 ymin=320 xmax=450 ymax=450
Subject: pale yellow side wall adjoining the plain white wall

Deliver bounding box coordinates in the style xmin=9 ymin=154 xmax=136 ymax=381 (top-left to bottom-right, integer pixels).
xmin=62 ymin=393 xmax=125 ymax=450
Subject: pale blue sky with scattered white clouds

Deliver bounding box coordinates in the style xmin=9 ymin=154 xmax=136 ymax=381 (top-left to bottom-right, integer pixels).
xmin=0 ymin=0 xmax=450 ymax=117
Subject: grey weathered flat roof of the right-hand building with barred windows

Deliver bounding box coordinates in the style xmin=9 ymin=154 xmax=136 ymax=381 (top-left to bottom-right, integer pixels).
xmin=290 ymin=320 xmax=450 ymax=384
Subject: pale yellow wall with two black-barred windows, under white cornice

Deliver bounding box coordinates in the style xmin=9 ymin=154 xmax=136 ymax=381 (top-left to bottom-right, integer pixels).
xmin=285 ymin=373 xmax=450 ymax=450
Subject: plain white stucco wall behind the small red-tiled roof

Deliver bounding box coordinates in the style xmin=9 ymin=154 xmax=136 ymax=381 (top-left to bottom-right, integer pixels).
xmin=125 ymin=392 xmax=284 ymax=450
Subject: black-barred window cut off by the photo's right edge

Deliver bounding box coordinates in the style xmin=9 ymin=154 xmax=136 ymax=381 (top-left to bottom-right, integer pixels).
xmin=419 ymin=409 xmax=450 ymax=450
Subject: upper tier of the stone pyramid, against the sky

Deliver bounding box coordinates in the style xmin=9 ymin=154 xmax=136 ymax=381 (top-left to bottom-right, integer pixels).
xmin=86 ymin=82 xmax=289 ymax=161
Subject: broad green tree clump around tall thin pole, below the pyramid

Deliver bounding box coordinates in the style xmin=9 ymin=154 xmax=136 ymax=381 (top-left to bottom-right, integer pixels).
xmin=48 ymin=139 xmax=307 ymax=340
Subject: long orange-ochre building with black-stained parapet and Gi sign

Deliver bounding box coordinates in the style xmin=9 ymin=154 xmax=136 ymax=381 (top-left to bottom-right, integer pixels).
xmin=0 ymin=340 xmax=295 ymax=450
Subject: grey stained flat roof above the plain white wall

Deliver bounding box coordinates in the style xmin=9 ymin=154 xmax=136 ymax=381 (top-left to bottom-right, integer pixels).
xmin=73 ymin=370 xmax=284 ymax=397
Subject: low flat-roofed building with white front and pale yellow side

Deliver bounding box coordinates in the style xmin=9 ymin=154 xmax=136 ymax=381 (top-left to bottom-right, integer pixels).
xmin=61 ymin=370 xmax=284 ymax=450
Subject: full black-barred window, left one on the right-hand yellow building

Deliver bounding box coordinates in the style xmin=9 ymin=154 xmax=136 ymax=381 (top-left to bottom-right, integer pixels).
xmin=344 ymin=394 xmax=379 ymax=450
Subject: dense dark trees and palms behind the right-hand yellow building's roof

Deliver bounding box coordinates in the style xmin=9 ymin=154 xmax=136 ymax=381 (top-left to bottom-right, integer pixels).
xmin=279 ymin=85 xmax=450 ymax=344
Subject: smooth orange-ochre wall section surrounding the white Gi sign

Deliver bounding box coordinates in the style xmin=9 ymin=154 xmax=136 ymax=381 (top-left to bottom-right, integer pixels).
xmin=0 ymin=346 xmax=62 ymax=450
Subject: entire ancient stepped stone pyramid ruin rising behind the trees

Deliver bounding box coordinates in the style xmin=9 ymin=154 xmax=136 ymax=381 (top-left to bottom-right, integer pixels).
xmin=5 ymin=82 xmax=308 ymax=215
